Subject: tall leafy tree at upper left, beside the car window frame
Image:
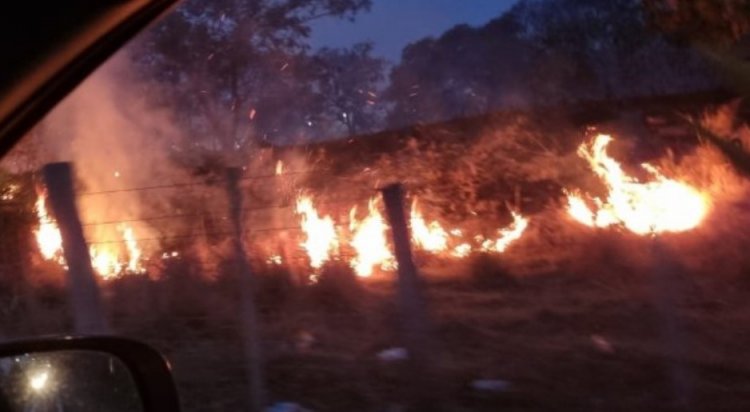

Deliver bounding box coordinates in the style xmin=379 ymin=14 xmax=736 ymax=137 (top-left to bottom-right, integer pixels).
xmin=134 ymin=0 xmax=370 ymax=154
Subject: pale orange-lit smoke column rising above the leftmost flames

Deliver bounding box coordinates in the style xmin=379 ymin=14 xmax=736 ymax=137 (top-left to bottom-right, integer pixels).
xmin=41 ymin=53 xmax=188 ymax=258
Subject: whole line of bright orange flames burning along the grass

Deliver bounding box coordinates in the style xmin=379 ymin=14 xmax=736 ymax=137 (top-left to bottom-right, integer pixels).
xmin=25 ymin=121 xmax=747 ymax=290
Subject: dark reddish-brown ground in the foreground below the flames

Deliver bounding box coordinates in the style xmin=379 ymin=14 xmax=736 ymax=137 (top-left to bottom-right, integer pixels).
xmin=82 ymin=240 xmax=750 ymax=411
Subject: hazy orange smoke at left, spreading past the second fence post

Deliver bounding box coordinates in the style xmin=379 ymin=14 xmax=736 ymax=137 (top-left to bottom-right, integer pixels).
xmin=35 ymin=53 xmax=320 ymax=269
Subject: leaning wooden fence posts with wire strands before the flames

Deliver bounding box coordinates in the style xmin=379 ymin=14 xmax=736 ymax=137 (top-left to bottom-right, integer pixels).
xmin=36 ymin=163 xmax=431 ymax=412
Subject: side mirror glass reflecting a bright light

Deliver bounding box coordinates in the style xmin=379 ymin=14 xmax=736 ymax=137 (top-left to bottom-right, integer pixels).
xmin=0 ymin=351 xmax=143 ymax=412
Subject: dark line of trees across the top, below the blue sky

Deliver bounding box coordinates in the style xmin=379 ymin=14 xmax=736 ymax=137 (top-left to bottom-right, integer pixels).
xmin=125 ymin=0 xmax=747 ymax=153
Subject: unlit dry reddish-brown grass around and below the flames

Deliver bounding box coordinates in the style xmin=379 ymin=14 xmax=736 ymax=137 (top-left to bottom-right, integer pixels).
xmin=7 ymin=102 xmax=750 ymax=412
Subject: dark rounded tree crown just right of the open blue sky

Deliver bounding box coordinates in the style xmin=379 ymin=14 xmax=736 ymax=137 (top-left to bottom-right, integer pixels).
xmin=386 ymin=15 xmax=530 ymax=126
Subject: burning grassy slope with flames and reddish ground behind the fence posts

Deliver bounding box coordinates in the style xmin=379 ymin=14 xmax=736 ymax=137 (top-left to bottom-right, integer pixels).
xmin=6 ymin=100 xmax=750 ymax=411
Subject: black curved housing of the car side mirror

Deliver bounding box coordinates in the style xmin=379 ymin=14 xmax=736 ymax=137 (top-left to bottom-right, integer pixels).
xmin=0 ymin=336 xmax=180 ymax=412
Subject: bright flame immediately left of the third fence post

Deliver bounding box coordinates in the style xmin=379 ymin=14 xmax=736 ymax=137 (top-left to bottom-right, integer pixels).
xmin=349 ymin=198 xmax=395 ymax=277
